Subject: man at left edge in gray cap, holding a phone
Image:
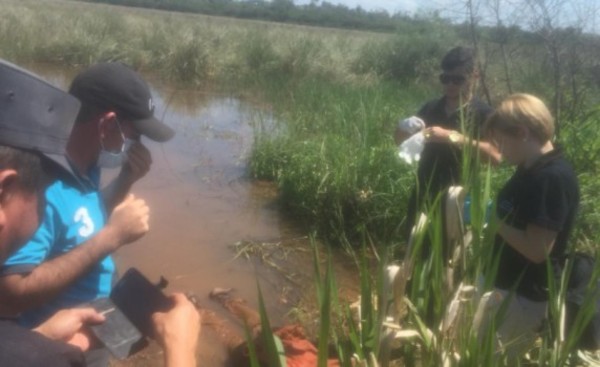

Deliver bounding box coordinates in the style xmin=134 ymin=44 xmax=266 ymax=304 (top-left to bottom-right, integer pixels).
xmin=0 ymin=60 xmax=199 ymax=367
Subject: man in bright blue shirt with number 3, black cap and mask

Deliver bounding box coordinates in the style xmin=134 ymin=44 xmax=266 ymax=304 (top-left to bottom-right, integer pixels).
xmin=0 ymin=63 xmax=174 ymax=364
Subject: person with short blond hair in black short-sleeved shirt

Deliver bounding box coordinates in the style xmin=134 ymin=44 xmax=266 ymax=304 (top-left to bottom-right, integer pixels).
xmin=475 ymin=94 xmax=579 ymax=357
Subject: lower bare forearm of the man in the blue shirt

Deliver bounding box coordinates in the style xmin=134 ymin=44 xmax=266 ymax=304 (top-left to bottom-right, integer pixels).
xmin=0 ymin=227 xmax=118 ymax=315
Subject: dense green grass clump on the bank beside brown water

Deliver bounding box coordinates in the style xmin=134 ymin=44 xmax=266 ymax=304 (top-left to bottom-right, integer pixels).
xmin=250 ymin=79 xmax=432 ymax=249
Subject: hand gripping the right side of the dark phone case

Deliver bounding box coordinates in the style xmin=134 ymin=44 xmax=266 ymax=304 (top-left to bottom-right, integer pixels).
xmin=152 ymin=293 xmax=200 ymax=367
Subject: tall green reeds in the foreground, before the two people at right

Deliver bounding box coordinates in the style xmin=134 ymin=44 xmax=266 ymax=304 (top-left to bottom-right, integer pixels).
xmin=252 ymin=115 xmax=600 ymax=367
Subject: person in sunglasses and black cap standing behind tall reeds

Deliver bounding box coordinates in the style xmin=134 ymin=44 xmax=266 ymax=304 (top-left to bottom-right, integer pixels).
xmin=395 ymin=47 xmax=501 ymax=327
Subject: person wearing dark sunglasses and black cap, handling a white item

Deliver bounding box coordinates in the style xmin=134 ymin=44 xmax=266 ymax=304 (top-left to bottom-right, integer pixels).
xmin=394 ymin=47 xmax=501 ymax=242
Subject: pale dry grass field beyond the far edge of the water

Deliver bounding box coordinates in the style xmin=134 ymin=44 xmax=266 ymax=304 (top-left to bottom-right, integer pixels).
xmin=0 ymin=0 xmax=388 ymax=85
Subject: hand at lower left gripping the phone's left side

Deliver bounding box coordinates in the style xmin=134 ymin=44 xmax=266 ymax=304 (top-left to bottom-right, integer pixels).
xmin=33 ymin=308 xmax=104 ymax=352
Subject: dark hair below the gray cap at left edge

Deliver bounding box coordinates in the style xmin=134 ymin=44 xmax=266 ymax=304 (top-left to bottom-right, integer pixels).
xmin=0 ymin=145 xmax=55 ymax=193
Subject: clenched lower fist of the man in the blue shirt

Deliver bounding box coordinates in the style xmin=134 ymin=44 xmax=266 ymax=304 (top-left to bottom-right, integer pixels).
xmin=102 ymin=194 xmax=150 ymax=248
